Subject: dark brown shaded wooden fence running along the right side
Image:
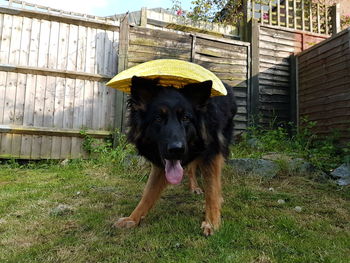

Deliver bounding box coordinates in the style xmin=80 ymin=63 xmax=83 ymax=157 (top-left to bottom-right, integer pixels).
xmin=297 ymin=28 xmax=350 ymax=141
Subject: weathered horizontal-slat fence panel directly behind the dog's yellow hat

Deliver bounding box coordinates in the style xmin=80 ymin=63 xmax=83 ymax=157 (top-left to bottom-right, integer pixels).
xmin=117 ymin=24 xmax=250 ymax=133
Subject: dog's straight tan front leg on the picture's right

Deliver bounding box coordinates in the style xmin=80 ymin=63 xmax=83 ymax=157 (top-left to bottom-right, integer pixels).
xmin=201 ymin=154 xmax=224 ymax=236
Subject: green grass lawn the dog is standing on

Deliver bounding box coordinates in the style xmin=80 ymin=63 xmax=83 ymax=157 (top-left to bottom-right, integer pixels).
xmin=0 ymin=161 xmax=350 ymax=263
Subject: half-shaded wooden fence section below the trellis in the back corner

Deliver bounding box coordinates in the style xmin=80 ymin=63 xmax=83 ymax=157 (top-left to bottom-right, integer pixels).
xmin=251 ymin=21 xmax=327 ymax=125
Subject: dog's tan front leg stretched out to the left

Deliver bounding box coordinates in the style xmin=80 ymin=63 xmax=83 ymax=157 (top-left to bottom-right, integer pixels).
xmin=115 ymin=164 xmax=167 ymax=228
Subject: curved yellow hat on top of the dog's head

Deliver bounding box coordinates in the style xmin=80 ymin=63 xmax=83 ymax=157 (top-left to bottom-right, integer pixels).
xmin=106 ymin=59 xmax=227 ymax=96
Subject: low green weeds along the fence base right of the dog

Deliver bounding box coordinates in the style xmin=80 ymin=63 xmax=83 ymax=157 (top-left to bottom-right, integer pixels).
xmin=232 ymin=118 xmax=350 ymax=172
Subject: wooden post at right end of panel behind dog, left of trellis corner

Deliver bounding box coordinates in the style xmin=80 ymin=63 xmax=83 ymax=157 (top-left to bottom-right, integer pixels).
xmin=249 ymin=19 xmax=260 ymax=124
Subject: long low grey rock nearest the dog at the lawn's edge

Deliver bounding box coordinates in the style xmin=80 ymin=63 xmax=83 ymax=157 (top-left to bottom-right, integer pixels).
xmin=227 ymin=158 xmax=278 ymax=177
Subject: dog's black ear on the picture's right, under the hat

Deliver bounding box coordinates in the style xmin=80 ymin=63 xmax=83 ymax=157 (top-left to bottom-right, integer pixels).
xmin=180 ymin=80 xmax=213 ymax=107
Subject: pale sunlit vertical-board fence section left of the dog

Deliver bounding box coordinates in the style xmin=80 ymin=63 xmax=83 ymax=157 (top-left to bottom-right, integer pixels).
xmin=0 ymin=1 xmax=119 ymax=159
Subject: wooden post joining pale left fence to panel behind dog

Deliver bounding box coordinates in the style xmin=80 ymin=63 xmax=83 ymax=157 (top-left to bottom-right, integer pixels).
xmin=113 ymin=14 xmax=129 ymax=146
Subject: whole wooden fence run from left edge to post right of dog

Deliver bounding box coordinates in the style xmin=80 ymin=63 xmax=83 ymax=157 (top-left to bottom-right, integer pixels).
xmin=0 ymin=0 xmax=250 ymax=159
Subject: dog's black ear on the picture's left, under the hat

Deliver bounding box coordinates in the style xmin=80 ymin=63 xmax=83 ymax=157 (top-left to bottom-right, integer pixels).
xmin=131 ymin=76 xmax=160 ymax=106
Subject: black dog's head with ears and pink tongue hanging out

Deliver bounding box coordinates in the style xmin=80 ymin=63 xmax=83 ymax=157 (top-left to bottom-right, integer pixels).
xmin=129 ymin=77 xmax=212 ymax=184
